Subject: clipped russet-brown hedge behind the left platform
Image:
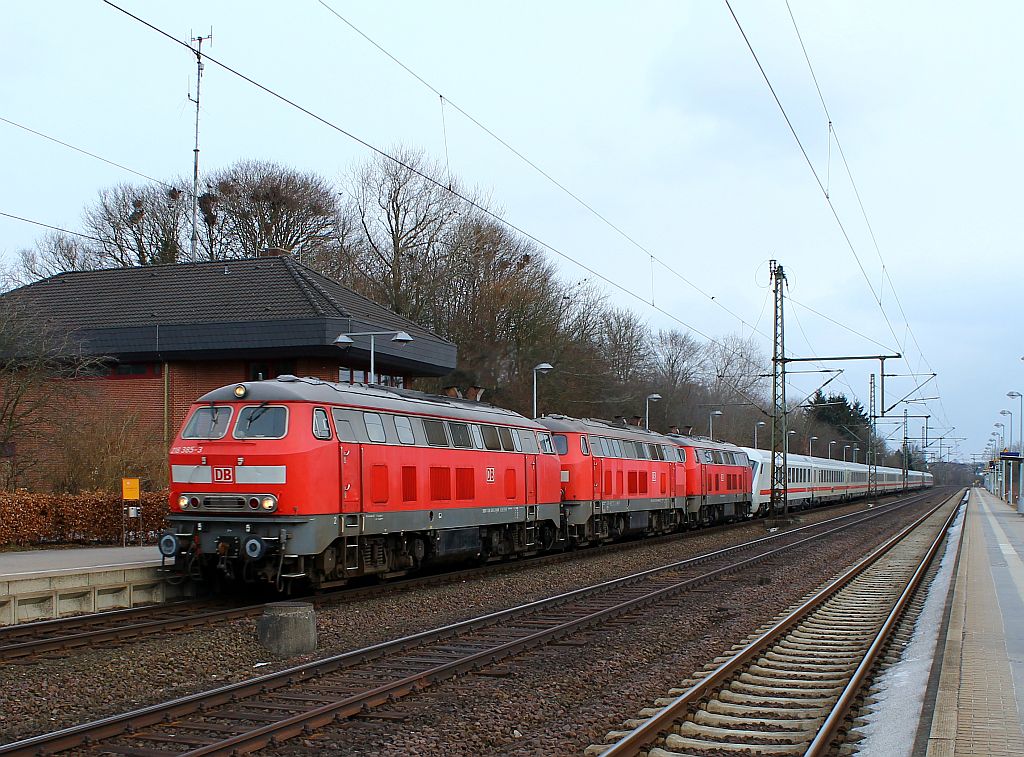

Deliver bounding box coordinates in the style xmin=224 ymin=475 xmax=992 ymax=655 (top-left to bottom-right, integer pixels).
xmin=0 ymin=490 xmax=168 ymax=547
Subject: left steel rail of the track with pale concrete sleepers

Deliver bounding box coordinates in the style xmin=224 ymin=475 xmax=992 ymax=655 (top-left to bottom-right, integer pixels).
xmin=600 ymin=493 xmax=959 ymax=757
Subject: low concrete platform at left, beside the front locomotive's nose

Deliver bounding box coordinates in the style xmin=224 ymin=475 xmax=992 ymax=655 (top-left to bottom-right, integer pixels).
xmin=0 ymin=545 xmax=182 ymax=626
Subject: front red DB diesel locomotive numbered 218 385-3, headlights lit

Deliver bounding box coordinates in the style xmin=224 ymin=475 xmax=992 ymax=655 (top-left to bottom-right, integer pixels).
xmin=160 ymin=376 xmax=561 ymax=589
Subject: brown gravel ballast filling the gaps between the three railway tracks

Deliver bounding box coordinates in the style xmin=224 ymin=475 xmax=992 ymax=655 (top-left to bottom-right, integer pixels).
xmin=0 ymin=491 xmax=937 ymax=755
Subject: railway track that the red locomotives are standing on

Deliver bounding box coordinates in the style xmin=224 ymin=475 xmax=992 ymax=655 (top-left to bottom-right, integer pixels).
xmin=0 ymin=491 xmax=937 ymax=663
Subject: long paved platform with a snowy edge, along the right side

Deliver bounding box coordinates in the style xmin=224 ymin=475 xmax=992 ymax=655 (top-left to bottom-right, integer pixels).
xmin=919 ymin=489 xmax=1024 ymax=757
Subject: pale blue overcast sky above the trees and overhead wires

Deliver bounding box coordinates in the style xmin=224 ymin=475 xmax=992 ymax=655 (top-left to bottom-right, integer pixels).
xmin=0 ymin=0 xmax=1024 ymax=459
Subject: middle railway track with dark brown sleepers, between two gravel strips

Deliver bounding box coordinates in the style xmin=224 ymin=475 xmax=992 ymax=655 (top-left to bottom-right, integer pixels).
xmin=0 ymin=493 xmax=946 ymax=757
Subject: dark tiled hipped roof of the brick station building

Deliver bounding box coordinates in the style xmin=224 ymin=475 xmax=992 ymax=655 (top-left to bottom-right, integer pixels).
xmin=3 ymin=255 xmax=456 ymax=375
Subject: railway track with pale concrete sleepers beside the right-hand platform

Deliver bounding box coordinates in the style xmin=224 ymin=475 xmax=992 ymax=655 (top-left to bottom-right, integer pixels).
xmin=588 ymin=487 xmax=968 ymax=757
